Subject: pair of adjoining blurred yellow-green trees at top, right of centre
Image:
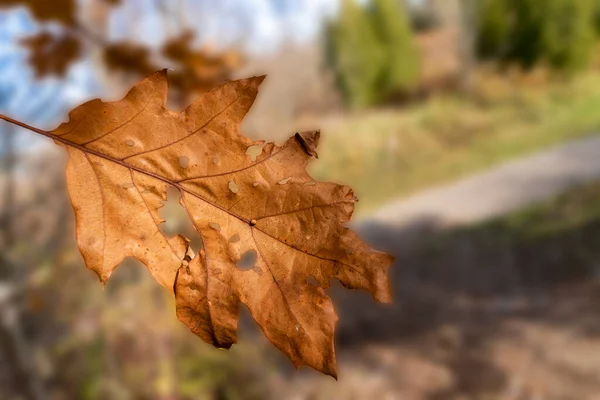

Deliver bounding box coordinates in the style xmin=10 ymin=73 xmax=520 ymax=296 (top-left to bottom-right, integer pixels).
xmin=326 ymin=0 xmax=419 ymax=108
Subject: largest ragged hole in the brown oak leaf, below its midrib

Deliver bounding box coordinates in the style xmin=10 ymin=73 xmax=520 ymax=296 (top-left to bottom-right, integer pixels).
xmin=158 ymin=186 xmax=203 ymax=253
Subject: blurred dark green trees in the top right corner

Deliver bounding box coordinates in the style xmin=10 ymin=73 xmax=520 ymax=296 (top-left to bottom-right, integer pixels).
xmin=477 ymin=0 xmax=596 ymax=72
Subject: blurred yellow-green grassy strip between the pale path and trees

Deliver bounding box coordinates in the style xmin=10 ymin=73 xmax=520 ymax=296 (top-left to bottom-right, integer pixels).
xmin=313 ymin=71 xmax=600 ymax=213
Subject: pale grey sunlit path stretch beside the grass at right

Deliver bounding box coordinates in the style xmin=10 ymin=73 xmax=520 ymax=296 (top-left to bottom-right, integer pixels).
xmin=364 ymin=136 xmax=600 ymax=227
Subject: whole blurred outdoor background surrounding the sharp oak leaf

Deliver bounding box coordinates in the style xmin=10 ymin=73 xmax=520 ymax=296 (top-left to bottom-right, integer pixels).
xmin=0 ymin=0 xmax=600 ymax=400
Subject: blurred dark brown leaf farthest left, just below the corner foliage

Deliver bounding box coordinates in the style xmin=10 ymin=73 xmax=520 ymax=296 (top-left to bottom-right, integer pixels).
xmin=21 ymin=32 xmax=81 ymax=78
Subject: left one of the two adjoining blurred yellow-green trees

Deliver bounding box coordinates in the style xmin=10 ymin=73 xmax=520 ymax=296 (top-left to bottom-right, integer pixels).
xmin=326 ymin=0 xmax=385 ymax=108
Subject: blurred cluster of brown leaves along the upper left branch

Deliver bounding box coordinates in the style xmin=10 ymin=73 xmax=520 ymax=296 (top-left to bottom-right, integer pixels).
xmin=0 ymin=0 xmax=242 ymax=102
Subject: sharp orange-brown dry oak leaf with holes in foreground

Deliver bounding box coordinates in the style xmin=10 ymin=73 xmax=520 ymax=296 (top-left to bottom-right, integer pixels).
xmin=51 ymin=71 xmax=392 ymax=376
